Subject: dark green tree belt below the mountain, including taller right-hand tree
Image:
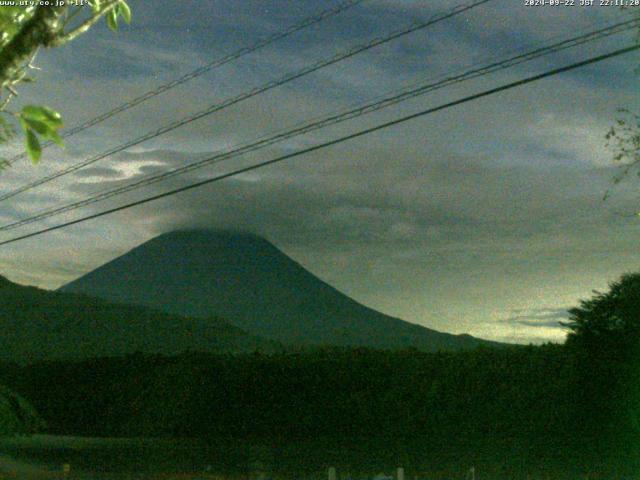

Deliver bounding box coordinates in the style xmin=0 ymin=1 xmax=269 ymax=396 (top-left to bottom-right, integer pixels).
xmin=0 ymin=274 xmax=640 ymax=478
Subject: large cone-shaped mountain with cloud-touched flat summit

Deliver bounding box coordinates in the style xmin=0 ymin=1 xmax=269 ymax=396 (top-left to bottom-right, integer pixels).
xmin=61 ymin=230 xmax=498 ymax=350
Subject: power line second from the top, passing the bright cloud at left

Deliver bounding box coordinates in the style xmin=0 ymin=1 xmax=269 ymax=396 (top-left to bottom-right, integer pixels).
xmin=0 ymin=0 xmax=492 ymax=201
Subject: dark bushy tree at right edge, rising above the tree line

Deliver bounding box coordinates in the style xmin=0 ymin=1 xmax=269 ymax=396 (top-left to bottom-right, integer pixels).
xmin=564 ymin=273 xmax=640 ymax=456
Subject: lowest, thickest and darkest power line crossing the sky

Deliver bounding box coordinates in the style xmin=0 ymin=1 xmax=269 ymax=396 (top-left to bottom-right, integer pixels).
xmin=0 ymin=45 xmax=640 ymax=246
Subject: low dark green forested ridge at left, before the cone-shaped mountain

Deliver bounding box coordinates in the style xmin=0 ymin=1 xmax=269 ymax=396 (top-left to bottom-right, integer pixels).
xmin=0 ymin=276 xmax=276 ymax=362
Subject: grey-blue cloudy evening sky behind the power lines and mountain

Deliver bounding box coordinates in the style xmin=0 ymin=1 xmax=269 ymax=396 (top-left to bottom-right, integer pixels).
xmin=0 ymin=0 xmax=640 ymax=343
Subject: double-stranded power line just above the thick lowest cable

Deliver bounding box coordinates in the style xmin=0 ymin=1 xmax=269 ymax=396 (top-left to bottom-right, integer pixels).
xmin=0 ymin=19 xmax=640 ymax=231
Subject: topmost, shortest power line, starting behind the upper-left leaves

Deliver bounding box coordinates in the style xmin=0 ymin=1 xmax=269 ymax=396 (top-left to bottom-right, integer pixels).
xmin=9 ymin=0 xmax=365 ymax=164
